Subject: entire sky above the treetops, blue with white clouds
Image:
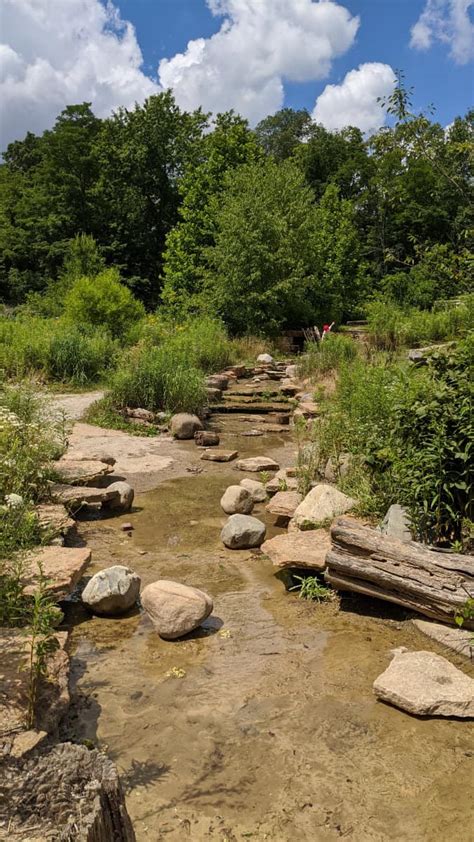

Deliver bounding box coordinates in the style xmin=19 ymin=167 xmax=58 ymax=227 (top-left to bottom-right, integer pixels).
xmin=0 ymin=0 xmax=474 ymax=149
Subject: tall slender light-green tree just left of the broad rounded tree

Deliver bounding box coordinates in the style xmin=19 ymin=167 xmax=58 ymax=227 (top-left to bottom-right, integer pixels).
xmin=162 ymin=111 xmax=262 ymax=316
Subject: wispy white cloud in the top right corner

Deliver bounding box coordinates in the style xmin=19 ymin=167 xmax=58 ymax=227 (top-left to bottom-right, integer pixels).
xmin=410 ymin=0 xmax=474 ymax=64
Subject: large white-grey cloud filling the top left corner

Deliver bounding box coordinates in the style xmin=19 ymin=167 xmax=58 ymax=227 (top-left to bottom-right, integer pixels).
xmin=0 ymin=0 xmax=159 ymax=149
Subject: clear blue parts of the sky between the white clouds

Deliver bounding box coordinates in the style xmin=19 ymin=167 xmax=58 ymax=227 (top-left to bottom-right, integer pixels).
xmin=116 ymin=0 xmax=474 ymax=125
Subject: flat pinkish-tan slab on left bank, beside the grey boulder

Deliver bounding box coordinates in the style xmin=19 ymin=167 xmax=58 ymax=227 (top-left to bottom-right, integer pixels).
xmin=23 ymin=547 xmax=91 ymax=601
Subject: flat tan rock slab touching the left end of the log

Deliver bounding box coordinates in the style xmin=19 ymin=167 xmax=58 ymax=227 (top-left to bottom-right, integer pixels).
xmin=261 ymin=529 xmax=331 ymax=572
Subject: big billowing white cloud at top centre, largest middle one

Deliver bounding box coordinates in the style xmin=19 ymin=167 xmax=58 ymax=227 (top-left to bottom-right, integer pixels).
xmin=159 ymin=0 xmax=359 ymax=124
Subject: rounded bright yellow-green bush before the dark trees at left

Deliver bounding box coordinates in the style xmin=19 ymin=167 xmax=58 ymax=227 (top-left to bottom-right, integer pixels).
xmin=64 ymin=269 xmax=145 ymax=336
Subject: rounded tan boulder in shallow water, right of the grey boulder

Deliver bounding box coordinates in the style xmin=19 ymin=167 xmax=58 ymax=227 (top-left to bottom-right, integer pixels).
xmin=141 ymin=579 xmax=213 ymax=640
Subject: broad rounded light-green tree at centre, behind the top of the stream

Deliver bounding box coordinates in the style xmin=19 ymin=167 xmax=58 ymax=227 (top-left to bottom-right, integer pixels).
xmin=201 ymin=158 xmax=360 ymax=334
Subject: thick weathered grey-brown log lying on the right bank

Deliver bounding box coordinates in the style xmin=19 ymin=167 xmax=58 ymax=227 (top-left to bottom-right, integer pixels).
xmin=325 ymin=518 xmax=474 ymax=628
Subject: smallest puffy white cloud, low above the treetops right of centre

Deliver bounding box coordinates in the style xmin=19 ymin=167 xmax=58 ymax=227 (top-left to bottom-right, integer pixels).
xmin=312 ymin=62 xmax=396 ymax=132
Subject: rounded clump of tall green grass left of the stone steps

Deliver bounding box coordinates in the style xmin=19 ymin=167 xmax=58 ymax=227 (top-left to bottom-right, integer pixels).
xmin=111 ymin=345 xmax=206 ymax=412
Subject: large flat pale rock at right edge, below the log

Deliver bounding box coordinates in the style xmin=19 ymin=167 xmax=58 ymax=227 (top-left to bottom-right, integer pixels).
xmin=373 ymin=652 xmax=474 ymax=719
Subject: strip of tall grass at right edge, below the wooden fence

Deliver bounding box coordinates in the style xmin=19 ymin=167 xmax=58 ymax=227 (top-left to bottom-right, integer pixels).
xmin=367 ymin=295 xmax=474 ymax=351
